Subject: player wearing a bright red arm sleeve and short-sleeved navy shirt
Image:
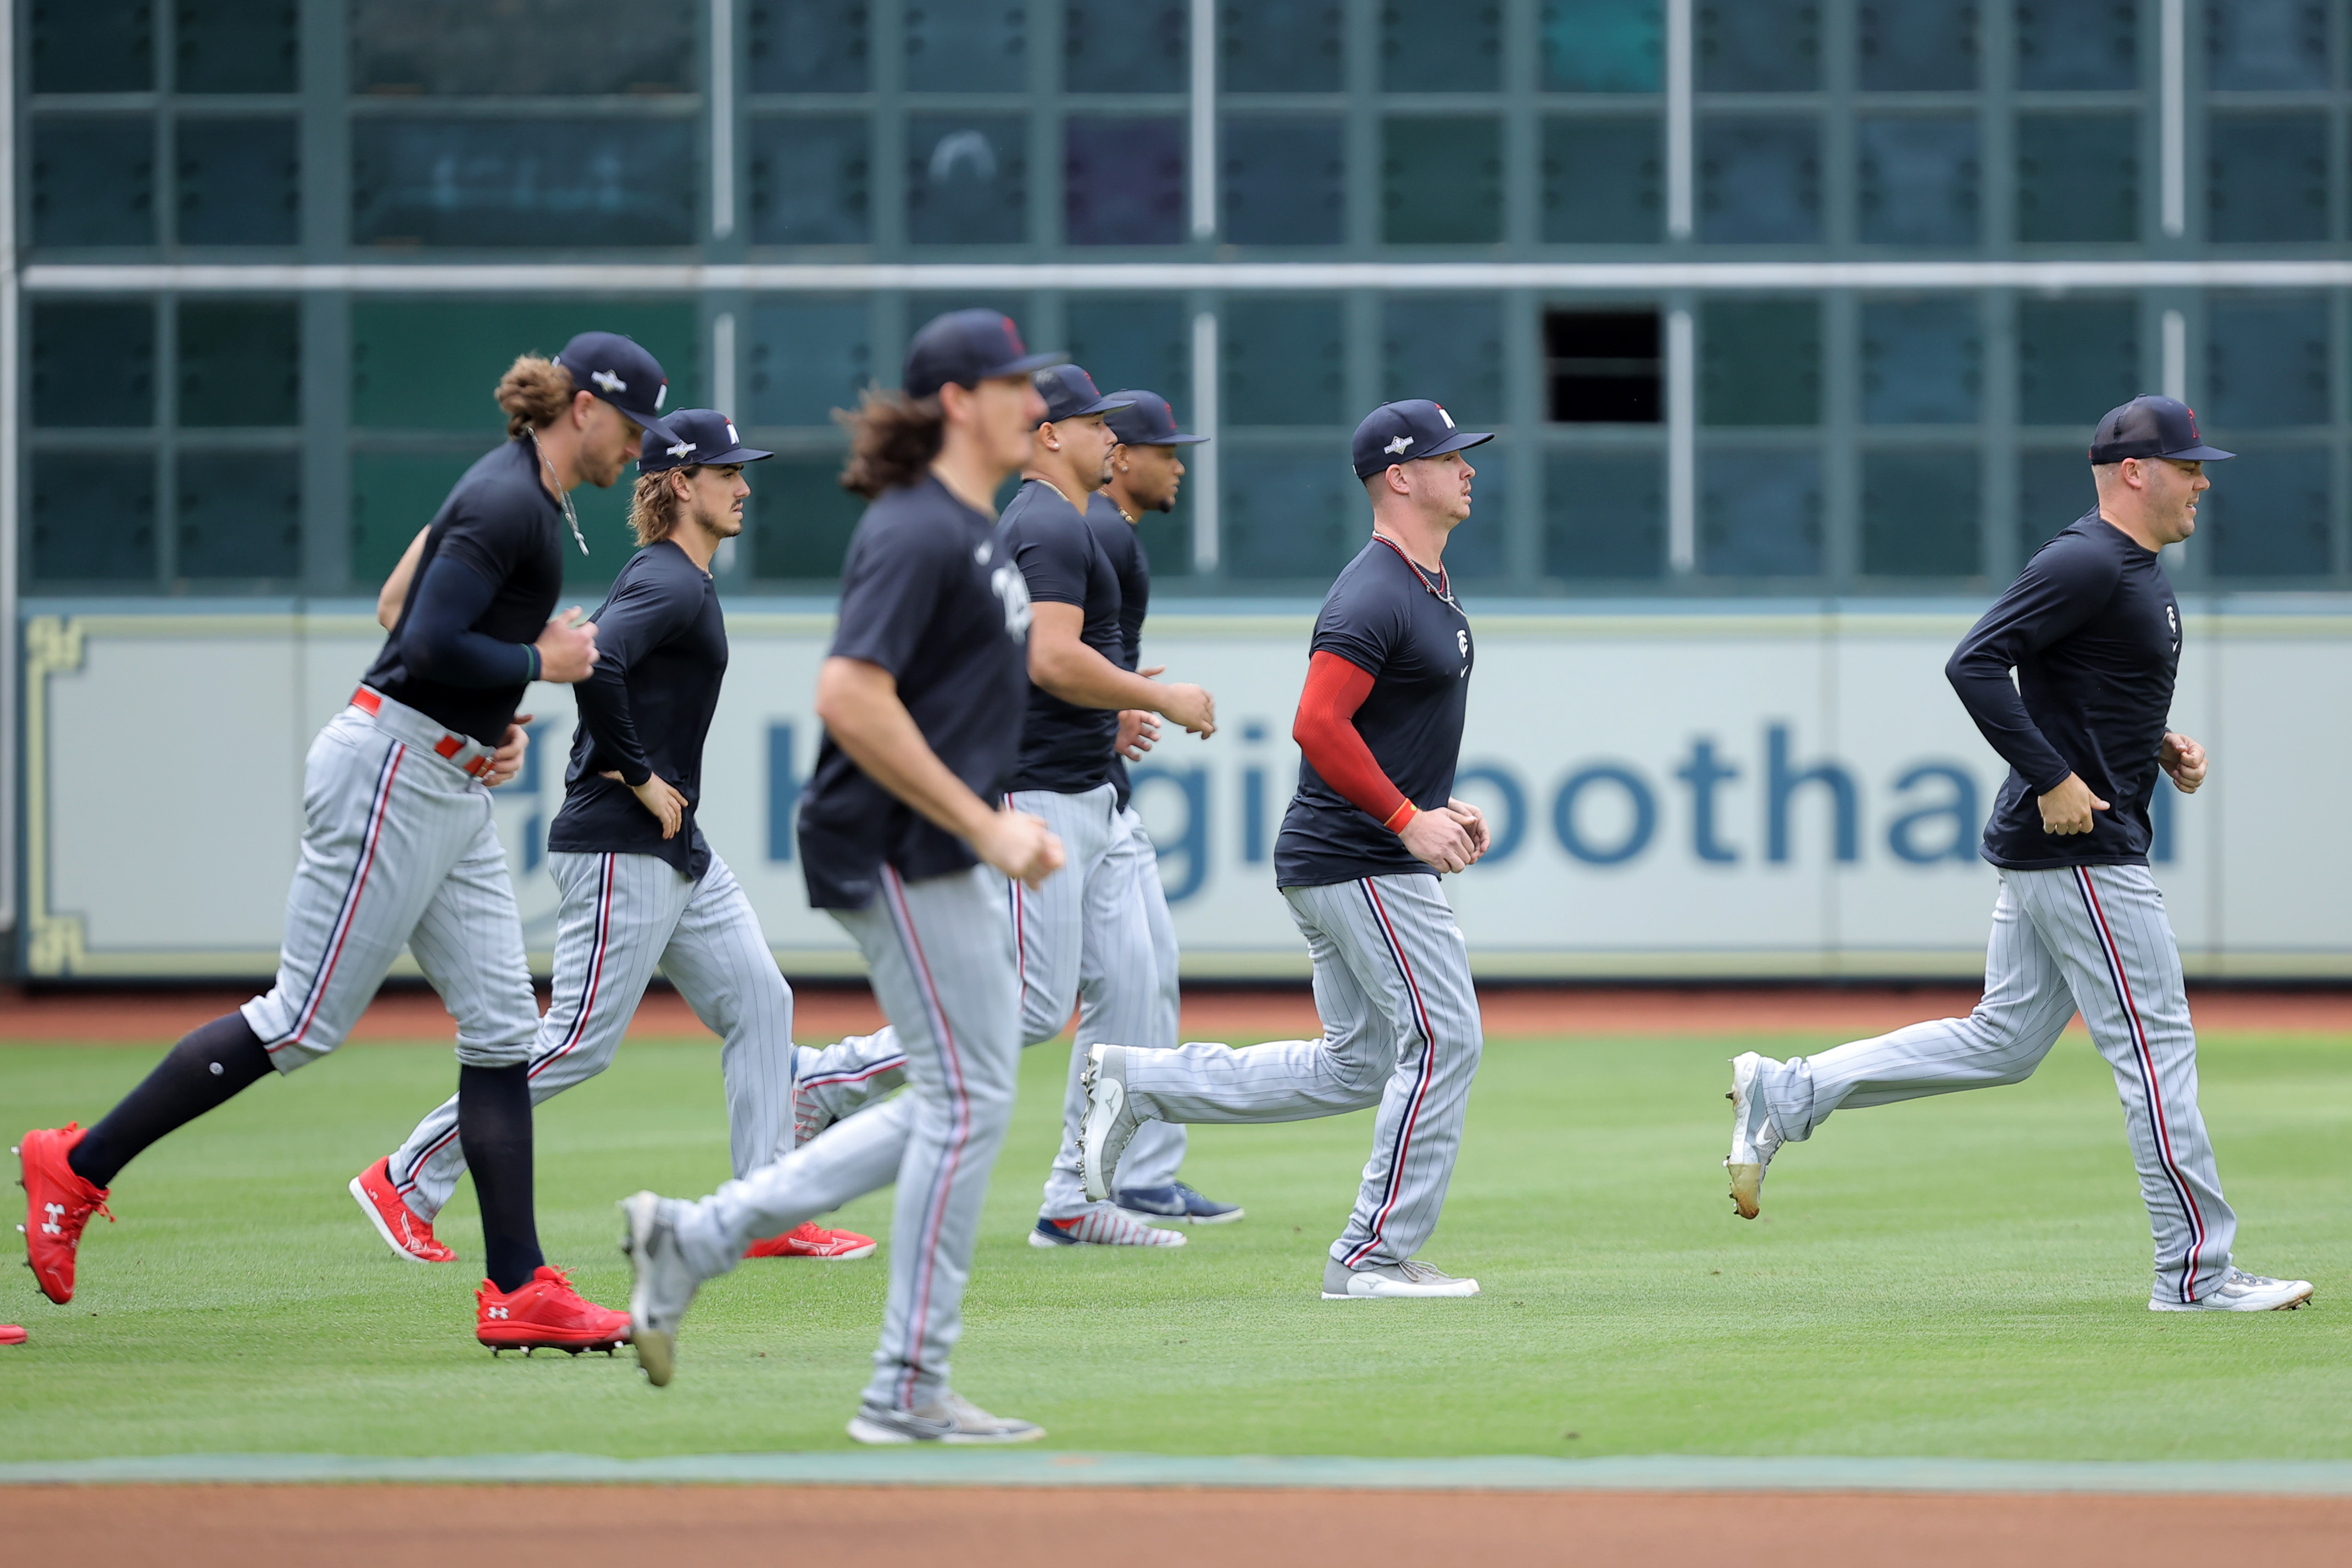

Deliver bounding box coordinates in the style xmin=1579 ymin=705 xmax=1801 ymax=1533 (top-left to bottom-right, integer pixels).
xmin=1080 ymin=399 xmax=1493 ymax=1300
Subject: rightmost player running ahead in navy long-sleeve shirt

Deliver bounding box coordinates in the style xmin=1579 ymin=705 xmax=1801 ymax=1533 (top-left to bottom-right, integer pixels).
xmin=1724 ymin=397 xmax=2312 ymax=1312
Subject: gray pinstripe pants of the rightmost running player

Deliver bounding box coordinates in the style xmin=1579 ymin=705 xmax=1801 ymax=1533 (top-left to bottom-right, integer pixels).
xmin=1761 ymin=865 xmax=2237 ymax=1302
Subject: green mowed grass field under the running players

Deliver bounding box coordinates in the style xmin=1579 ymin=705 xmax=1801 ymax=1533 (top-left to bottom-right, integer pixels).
xmin=0 ymin=1035 xmax=2352 ymax=1460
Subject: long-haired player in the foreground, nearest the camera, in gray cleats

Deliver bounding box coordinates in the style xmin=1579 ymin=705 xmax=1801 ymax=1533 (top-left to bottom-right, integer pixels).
xmin=621 ymin=310 xmax=1063 ymax=1443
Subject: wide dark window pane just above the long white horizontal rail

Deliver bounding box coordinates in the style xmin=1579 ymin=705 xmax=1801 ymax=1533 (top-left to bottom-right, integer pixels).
xmin=351 ymin=120 xmax=701 ymax=247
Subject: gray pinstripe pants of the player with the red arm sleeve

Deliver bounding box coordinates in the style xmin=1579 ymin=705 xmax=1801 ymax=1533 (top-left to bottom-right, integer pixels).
xmin=1127 ymin=875 xmax=1484 ymax=1270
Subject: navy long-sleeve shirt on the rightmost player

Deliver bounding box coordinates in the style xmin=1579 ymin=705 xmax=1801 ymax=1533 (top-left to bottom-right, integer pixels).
xmin=1943 ymin=508 xmax=2180 ymax=870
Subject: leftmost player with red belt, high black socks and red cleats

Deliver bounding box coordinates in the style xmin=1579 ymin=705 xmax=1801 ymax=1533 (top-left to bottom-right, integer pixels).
xmin=19 ymin=331 xmax=675 ymax=1352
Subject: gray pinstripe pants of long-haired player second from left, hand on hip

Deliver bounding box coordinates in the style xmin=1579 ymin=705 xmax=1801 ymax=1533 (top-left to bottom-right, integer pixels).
xmin=391 ymin=851 xmax=793 ymax=1220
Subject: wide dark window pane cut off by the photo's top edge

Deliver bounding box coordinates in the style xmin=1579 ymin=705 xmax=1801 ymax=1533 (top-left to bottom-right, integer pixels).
xmin=348 ymin=0 xmax=701 ymax=96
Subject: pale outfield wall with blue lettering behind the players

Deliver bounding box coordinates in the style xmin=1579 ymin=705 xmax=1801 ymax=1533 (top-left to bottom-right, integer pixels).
xmin=24 ymin=599 xmax=2352 ymax=978
